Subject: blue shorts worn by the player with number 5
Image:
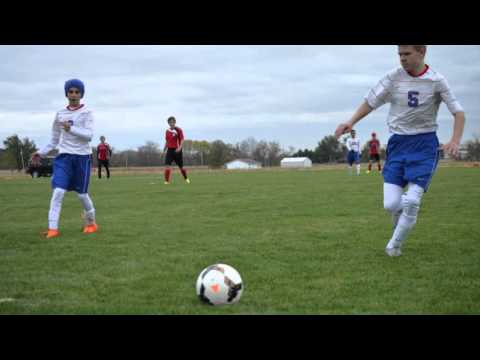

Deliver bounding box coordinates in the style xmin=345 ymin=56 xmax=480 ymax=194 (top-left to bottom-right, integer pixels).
xmin=383 ymin=132 xmax=440 ymax=191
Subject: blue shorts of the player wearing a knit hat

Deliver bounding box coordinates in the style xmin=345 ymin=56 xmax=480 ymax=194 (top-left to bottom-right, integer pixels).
xmin=52 ymin=154 xmax=92 ymax=194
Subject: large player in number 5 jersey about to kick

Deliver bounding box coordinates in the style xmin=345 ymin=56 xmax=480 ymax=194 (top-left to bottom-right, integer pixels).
xmin=335 ymin=45 xmax=465 ymax=256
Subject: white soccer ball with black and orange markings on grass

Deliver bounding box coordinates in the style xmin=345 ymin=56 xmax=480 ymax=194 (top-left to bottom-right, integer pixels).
xmin=196 ymin=264 xmax=244 ymax=305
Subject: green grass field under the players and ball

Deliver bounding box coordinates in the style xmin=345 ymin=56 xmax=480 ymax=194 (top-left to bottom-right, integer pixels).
xmin=0 ymin=167 xmax=480 ymax=314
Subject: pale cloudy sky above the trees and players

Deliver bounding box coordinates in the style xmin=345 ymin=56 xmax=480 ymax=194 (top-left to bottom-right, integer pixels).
xmin=0 ymin=45 xmax=480 ymax=150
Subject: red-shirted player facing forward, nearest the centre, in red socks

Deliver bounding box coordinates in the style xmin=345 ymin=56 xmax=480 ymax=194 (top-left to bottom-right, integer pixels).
xmin=163 ymin=116 xmax=190 ymax=185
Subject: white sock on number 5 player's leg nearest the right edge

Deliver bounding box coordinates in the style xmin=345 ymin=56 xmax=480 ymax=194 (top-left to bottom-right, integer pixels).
xmin=387 ymin=184 xmax=424 ymax=248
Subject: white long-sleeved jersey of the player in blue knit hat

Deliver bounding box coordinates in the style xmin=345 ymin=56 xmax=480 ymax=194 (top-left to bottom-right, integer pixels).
xmin=39 ymin=105 xmax=93 ymax=156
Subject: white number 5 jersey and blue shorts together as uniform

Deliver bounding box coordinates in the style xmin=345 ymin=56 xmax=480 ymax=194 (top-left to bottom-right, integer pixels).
xmin=365 ymin=65 xmax=463 ymax=191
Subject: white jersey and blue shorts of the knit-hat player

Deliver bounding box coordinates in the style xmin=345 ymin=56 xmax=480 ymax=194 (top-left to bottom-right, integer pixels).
xmin=39 ymin=105 xmax=94 ymax=194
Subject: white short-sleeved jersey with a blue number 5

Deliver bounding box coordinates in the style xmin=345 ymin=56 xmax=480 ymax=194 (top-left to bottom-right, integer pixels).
xmin=365 ymin=66 xmax=463 ymax=135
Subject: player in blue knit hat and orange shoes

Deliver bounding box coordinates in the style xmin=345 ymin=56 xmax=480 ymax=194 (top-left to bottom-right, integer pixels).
xmin=32 ymin=79 xmax=97 ymax=238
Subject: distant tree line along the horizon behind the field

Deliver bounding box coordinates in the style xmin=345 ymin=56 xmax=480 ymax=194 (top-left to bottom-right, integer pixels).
xmin=0 ymin=134 xmax=480 ymax=170
